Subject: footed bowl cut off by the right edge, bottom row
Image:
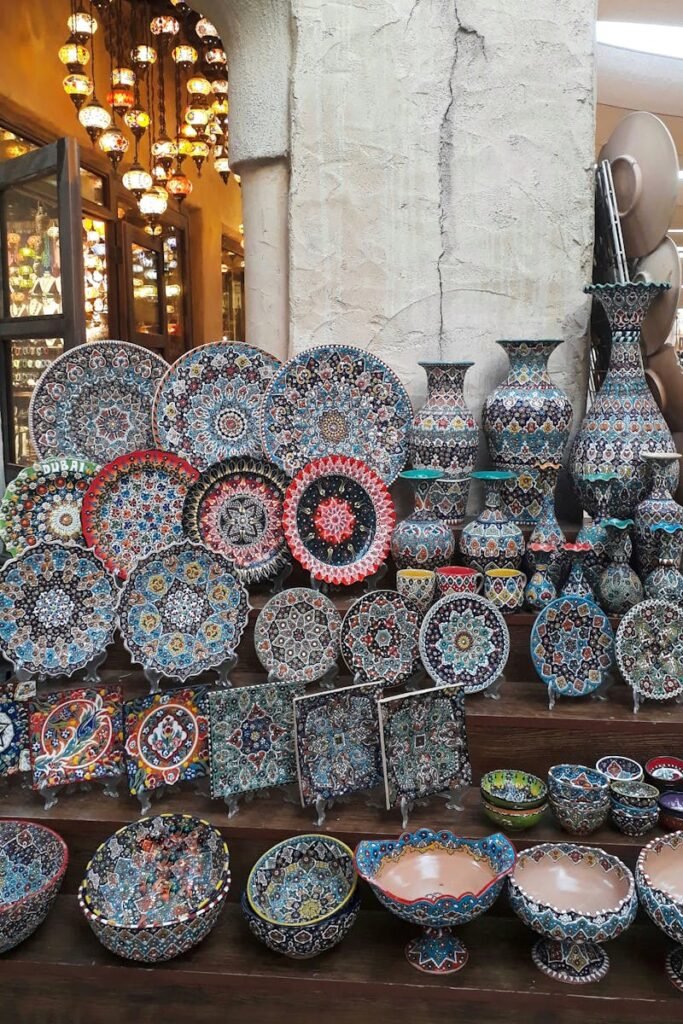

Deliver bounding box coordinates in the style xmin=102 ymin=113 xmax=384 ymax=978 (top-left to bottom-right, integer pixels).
xmin=636 ymin=831 xmax=683 ymax=990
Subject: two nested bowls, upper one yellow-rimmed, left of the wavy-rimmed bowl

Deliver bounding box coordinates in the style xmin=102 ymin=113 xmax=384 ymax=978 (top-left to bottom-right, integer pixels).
xmin=242 ymin=835 xmax=360 ymax=959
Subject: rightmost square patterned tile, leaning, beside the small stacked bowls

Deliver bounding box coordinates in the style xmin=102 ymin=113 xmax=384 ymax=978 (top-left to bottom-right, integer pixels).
xmin=378 ymin=687 xmax=472 ymax=808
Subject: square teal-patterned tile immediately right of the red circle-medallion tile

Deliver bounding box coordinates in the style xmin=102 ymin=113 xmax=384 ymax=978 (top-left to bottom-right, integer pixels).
xmin=208 ymin=682 xmax=303 ymax=798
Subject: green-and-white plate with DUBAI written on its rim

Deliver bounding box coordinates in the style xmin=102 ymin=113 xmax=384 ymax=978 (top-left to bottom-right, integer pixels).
xmin=0 ymin=459 xmax=99 ymax=555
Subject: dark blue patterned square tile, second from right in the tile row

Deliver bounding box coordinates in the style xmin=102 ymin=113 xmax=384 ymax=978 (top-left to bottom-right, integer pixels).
xmin=294 ymin=683 xmax=382 ymax=807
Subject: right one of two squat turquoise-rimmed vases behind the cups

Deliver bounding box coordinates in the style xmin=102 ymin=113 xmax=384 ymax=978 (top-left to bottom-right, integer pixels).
xmin=460 ymin=470 xmax=524 ymax=572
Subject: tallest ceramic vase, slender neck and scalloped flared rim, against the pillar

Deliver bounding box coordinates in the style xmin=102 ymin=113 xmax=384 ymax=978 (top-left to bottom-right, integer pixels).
xmin=569 ymin=283 xmax=678 ymax=517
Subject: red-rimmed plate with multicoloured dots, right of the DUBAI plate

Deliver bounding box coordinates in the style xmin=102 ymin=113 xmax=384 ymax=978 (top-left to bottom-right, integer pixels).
xmin=81 ymin=449 xmax=199 ymax=580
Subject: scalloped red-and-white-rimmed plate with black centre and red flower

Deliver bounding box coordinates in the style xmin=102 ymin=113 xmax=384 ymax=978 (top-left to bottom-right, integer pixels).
xmin=283 ymin=455 xmax=396 ymax=586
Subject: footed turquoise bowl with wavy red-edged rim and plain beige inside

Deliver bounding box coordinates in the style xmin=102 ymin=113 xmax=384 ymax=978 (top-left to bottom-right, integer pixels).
xmin=355 ymin=828 xmax=515 ymax=974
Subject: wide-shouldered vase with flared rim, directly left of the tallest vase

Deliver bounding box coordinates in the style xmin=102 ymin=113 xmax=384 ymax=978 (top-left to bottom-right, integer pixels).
xmin=483 ymin=339 xmax=572 ymax=523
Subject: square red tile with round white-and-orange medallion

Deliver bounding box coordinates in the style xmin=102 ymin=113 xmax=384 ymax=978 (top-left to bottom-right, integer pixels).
xmin=124 ymin=687 xmax=209 ymax=796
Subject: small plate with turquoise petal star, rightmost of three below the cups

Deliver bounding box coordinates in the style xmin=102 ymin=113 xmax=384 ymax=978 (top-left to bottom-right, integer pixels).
xmin=420 ymin=594 xmax=510 ymax=693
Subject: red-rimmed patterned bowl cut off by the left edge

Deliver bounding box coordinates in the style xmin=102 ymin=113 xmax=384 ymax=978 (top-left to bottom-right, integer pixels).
xmin=0 ymin=818 xmax=69 ymax=953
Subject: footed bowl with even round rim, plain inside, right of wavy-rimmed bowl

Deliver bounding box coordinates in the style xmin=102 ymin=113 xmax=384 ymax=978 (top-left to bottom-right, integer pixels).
xmin=509 ymin=843 xmax=638 ymax=984
